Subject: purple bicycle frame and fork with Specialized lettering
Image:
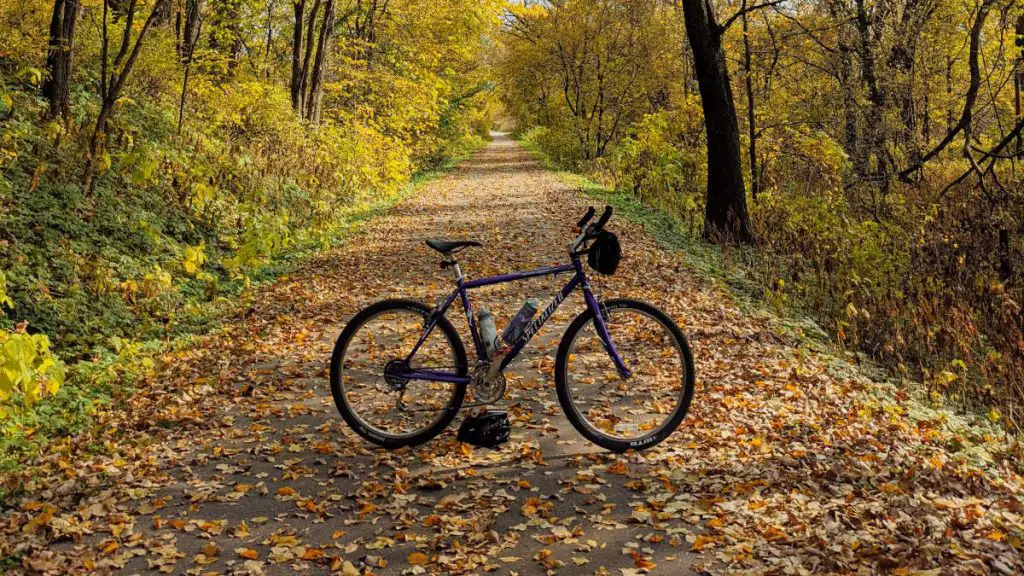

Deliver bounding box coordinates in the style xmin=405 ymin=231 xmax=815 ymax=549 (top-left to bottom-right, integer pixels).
xmin=388 ymin=255 xmax=632 ymax=384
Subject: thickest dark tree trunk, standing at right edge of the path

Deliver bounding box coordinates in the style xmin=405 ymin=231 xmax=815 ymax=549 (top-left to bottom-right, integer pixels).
xmin=683 ymin=0 xmax=754 ymax=243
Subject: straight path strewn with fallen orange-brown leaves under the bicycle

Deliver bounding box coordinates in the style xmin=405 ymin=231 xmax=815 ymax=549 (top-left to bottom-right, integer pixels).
xmin=2 ymin=137 xmax=1022 ymax=575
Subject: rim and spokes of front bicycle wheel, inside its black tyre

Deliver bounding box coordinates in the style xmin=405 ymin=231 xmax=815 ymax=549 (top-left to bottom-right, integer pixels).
xmin=565 ymin=307 xmax=687 ymax=446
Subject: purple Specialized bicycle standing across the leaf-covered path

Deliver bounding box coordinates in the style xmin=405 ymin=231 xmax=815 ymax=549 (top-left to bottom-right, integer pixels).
xmin=331 ymin=206 xmax=694 ymax=452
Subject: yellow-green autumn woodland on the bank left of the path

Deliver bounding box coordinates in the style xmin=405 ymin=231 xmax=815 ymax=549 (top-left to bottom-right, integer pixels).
xmin=0 ymin=0 xmax=498 ymax=464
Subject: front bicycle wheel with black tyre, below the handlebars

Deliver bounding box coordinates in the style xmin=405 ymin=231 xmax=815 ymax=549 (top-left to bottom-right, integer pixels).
xmin=555 ymin=299 xmax=694 ymax=452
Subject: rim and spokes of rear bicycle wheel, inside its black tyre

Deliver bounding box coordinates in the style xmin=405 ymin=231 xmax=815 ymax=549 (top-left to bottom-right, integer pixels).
xmin=339 ymin=310 xmax=459 ymax=439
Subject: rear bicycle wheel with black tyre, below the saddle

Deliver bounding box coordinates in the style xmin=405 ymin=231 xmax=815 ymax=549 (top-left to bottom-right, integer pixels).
xmin=331 ymin=300 xmax=468 ymax=449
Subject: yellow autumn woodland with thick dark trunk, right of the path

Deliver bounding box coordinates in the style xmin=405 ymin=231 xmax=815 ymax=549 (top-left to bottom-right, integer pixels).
xmin=496 ymin=0 xmax=1024 ymax=429
